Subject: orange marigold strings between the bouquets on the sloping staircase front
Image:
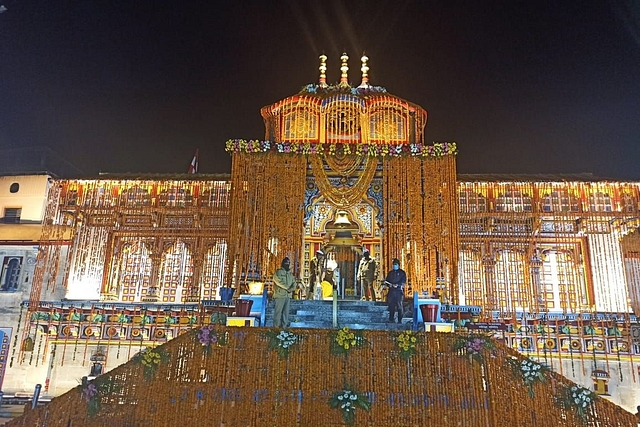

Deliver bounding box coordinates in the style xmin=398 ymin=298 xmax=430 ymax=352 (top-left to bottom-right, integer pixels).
xmin=8 ymin=328 xmax=637 ymax=427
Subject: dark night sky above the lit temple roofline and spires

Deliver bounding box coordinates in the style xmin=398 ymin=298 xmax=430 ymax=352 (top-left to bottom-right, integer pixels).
xmin=0 ymin=0 xmax=640 ymax=179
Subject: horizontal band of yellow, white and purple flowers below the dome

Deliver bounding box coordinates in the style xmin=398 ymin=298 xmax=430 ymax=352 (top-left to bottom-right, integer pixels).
xmin=225 ymin=139 xmax=458 ymax=157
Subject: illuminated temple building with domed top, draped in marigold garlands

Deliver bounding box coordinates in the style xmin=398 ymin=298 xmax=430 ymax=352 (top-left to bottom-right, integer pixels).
xmin=0 ymin=55 xmax=640 ymax=410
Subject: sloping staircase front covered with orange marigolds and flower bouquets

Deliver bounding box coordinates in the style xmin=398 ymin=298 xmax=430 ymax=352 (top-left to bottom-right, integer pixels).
xmin=7 ymin=326 xmax=637 ymax=427
